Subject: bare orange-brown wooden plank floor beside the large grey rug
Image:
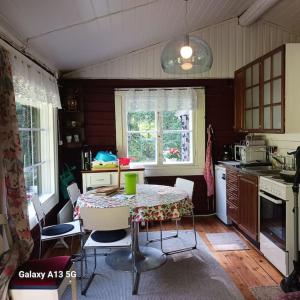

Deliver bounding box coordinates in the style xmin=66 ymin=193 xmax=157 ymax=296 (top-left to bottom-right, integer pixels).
xmin=46 ymin=217 xmax=282 ymax=299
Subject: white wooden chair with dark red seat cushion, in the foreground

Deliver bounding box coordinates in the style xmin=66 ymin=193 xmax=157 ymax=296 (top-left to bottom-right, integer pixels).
xmin=0 ymin=214 xmax=77 ymax=300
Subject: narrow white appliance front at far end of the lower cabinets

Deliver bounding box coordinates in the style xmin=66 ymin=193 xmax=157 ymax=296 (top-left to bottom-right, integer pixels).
xmin=215 ymin=165 xmax=231 ymax=224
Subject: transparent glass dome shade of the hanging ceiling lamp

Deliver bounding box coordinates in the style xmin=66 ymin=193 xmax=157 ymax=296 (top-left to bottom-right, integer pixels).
xmin=161 ymin=36 xmax=213 ymax=74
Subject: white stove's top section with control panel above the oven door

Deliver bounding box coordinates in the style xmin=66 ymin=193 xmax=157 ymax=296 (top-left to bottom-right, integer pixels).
xmin=259 ymin=175 xmax=293 ymax=201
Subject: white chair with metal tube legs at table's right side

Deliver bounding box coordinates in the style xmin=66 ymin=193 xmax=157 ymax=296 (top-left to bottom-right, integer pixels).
xmin=147 ymin=177 xmax=197 ymax=255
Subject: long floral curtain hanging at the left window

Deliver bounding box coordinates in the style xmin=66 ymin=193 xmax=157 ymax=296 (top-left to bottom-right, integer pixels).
xmin=0 ymin=47 xmax=33 ymax=300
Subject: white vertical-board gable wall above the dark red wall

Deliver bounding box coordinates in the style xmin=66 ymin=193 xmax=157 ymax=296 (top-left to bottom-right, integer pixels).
xmin=65 ymin=18 xmax=300 ymax=79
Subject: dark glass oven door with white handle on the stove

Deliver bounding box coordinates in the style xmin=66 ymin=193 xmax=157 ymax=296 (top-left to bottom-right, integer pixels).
xmin=259 ymin=192 xmax=286 ymax=250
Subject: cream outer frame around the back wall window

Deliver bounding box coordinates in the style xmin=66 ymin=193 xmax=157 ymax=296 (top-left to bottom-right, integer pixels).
xmin=115 ymin=88 xmax=205 ymax=177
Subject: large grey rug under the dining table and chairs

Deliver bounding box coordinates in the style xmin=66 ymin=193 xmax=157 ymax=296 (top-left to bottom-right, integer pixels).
xmin=62 ymin=231 xmax=244 ymax=300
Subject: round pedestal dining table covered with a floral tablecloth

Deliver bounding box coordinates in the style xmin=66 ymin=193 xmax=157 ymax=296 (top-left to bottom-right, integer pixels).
xmin=74 ymin=184 xmax=193 ymax=272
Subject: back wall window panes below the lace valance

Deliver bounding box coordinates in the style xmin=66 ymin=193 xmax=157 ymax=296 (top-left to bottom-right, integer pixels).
xmin=126 ymin=110 xmax=193 ymax=164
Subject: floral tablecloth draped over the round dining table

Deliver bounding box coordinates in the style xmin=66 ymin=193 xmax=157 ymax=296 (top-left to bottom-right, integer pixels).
xmin=75 ymin=184 xmax=193 ymax=222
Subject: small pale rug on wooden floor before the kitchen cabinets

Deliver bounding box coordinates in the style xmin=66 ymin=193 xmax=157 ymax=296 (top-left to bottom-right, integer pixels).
xmin=206 ymin=232 xmax=249 ymax=251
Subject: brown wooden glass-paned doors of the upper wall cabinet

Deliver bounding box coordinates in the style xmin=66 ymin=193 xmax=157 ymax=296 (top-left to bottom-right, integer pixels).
xmin=235 ymin=45 xmax=286 ymax=133
